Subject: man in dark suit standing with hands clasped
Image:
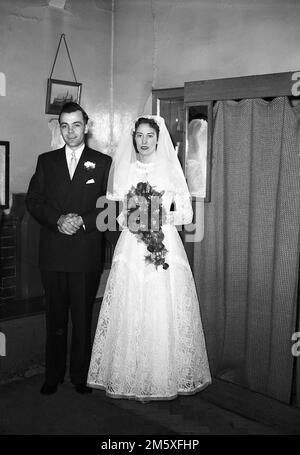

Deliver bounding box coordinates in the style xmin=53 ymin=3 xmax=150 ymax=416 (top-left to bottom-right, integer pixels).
xmin=26 ymin=102 xmax=111 ymax=395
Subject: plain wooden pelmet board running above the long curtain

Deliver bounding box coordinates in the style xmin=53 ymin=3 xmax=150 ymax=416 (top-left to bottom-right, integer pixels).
xmin=184 ymin=72 xmax=300 ymax=102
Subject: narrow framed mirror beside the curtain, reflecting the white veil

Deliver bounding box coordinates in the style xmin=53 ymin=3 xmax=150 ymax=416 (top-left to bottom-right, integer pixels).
xmin=184 ymin=101 xmax=213 ymax=202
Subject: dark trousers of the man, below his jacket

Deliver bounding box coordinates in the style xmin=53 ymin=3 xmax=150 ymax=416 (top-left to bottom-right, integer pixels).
xmin=41 ymin=270 xmax=101 ymax=385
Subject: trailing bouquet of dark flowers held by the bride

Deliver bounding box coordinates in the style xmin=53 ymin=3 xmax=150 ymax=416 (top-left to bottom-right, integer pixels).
xmin=125 ymin=182 xmax=169 ymax=270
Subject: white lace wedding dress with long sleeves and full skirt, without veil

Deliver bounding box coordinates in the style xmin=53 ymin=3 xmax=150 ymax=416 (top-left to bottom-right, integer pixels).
xmin=87 ymin=161 xmax=211 ymax=400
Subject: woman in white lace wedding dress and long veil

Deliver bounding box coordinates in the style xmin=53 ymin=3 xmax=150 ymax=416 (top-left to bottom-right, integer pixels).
xmin=87 ymin=116 xmax=211 ymax=401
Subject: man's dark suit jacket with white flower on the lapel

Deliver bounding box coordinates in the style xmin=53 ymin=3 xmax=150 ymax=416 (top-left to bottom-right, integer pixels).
xmin=26 ymin=146 xmax=111 ymax=272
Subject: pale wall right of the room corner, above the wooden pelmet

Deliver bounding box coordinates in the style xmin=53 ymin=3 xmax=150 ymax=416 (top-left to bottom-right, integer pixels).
xmin=114 ymin=0 xmax=300 ymax=132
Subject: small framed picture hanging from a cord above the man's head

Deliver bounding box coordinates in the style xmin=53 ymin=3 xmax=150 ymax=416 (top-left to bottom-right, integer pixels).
xmin=45 ymin=78 xmax=82 ymax=115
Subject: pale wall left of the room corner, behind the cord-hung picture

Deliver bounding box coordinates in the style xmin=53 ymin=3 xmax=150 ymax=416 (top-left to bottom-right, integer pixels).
xmin=0 ymin=0 xmax=112 ymax=193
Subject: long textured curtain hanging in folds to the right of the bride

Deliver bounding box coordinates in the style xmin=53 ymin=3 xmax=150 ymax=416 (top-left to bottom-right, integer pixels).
xmin=193 ymin=97 xmax=300 ymax=403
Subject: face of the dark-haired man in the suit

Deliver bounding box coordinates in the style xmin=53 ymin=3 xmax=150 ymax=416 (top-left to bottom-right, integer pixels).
xmin=60 ymin=111 xmax=88 ymax=150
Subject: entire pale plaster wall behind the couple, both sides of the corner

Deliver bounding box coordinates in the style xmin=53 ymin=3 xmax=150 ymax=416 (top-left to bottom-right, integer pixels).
xmin=0 ymin=0 xmax=300 ymax=196
